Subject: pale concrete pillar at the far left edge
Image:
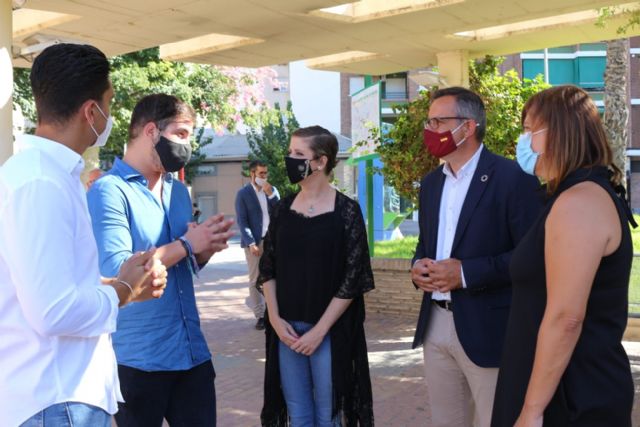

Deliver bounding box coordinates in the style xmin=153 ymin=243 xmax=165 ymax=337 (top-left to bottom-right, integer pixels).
xmin=0 ymin=0 xmax=13 ymax=165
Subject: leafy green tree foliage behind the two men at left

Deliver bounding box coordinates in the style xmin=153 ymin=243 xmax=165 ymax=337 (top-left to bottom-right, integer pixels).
xmin=14 ymin=48 xmax=275 ymax=177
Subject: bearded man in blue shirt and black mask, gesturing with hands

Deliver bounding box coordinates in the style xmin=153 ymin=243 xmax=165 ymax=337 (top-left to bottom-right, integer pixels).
xmin=88 ymin=94 xmax=232 ymax=427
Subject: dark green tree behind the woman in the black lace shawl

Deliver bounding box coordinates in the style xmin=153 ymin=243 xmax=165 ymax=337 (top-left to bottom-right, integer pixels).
xmin=247 ymin=102 xmax=299 ymax=196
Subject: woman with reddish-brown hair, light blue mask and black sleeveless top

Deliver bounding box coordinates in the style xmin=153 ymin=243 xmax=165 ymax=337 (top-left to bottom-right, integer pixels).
xmin=492 ymin=86 xmax=633 ymax=427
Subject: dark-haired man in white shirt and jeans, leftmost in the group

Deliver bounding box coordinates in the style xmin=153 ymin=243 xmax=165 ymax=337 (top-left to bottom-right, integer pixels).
xmin=0 ymin=44 xmax=166 ymax=427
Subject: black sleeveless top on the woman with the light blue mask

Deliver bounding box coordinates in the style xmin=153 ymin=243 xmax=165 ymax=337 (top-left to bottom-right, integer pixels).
xmin=491 ymin=167 xmax=634 ymax=427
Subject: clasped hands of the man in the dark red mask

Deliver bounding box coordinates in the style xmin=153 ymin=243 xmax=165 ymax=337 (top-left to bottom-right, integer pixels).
xmin=411 ymin=258 xmax=462 ymax=293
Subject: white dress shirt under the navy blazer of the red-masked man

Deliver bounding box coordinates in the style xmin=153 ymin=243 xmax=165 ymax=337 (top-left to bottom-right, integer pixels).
xmin=431 ymin=145 xmax=483 ymax=301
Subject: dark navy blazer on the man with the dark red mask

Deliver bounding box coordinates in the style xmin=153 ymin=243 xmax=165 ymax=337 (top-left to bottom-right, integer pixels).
xmin=413 ymin=147 xmax=543 ymax=367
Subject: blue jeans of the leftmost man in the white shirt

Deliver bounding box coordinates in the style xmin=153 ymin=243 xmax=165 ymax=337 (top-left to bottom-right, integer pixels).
xmin=20 ymin=402 xmax=111 ymax=427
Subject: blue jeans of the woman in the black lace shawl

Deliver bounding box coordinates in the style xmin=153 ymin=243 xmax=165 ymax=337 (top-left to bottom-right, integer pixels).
xmin=278 ymin=321 xmax=340 ymax=427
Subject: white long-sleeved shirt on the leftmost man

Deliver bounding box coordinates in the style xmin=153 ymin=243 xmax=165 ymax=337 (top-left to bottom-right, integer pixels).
xmin=0 ymin=135 xmax=122 ymax=427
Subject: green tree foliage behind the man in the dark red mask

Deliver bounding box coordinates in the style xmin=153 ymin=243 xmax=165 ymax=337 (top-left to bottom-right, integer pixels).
xmin=377 ymin=56 xmax=548 ymax=205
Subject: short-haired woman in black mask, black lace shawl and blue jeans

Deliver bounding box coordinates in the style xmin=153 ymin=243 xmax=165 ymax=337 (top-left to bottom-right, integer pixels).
xmin=257 ymin=126 xmax=373 ymax=427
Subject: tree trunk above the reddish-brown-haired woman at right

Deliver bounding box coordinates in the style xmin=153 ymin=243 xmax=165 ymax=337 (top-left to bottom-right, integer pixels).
xmin=604 ymin=38 xmax=629 ymax=183
